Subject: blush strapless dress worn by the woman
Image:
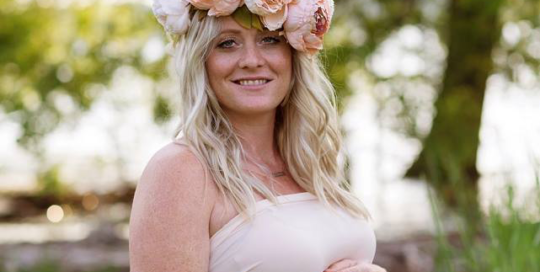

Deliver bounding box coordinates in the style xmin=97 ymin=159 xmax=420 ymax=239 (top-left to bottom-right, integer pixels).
xmin=210 ymin=192 xmax=376 ymax=272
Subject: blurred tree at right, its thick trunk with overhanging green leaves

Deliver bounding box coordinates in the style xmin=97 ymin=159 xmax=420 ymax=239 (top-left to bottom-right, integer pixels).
xmin=326 ymin=0 xmax=540 ymax=225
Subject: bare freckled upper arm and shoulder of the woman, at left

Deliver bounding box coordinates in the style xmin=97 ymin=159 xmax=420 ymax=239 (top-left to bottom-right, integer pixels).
xmin=129 ymin=144 xmax=214 ymax=272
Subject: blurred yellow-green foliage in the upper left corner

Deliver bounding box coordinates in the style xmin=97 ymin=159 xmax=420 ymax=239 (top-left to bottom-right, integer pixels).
xmin=0 ymin=0 xmax=166 ymax=151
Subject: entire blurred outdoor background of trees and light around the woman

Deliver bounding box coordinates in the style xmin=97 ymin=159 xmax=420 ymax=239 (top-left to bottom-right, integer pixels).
xmin=0 ymin=0 xmax=540 ymax=272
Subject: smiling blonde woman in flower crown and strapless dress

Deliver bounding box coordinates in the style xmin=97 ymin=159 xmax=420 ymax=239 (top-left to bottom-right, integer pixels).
xmin=130 ymin=0 xmax=385 ymax=272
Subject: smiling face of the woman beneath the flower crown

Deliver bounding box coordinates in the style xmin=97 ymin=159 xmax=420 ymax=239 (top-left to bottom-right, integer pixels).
xmin=206 ymin=16 xmax=292 ymax=115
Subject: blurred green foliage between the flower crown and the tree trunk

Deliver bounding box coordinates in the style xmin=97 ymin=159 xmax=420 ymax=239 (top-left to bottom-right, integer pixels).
xmin=323 ymin=0 xmax=426 ymax=111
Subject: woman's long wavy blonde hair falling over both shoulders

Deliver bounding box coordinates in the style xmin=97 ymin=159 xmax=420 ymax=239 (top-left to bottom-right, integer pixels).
xmin=174 ymin=11 xmax=369 ymax=219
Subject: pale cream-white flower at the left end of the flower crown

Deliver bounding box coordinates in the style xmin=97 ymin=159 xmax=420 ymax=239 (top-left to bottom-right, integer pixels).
xmin=152 ymin=0 xmax=190 ymax=35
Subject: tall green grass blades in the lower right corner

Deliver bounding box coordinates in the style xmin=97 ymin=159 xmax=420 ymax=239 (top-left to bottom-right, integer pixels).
xmin=431 ymin=186 xmax=540 ymax=272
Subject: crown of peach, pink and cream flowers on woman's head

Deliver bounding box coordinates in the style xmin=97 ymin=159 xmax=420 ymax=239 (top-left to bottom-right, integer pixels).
xmin=152 ymin=0 xmax=334 ymax=54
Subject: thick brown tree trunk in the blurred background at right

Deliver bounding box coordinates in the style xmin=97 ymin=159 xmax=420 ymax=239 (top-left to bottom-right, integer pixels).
xmin=406 ymin=0 xmax=504 ymax=227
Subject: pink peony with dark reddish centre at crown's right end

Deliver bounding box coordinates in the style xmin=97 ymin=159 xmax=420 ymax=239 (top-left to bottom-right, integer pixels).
xmin=283 ymin=0 xmax=334 ymax=54
